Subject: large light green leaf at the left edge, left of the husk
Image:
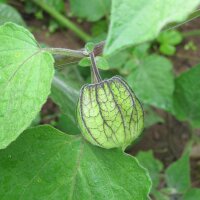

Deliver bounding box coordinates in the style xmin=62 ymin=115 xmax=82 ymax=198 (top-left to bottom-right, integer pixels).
xmin=0 ymin=23 xmax=54 ymax=148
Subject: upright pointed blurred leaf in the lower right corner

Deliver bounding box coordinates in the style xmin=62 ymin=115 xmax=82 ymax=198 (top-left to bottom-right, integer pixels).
xmin=165 ymin=152 xmax=191 ymax=193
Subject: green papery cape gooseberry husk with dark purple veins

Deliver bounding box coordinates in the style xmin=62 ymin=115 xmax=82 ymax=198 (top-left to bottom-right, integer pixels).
xmin=77 ymin=76 xmax=144 ymax=149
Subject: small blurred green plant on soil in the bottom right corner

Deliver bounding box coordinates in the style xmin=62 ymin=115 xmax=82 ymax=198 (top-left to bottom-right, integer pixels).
xmin=137 ymin=147 xmax=200 ymax=200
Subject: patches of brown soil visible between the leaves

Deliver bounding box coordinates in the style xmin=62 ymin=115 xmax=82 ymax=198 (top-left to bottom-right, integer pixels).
xmin=22 ymin=10 xmax=200 ymax=187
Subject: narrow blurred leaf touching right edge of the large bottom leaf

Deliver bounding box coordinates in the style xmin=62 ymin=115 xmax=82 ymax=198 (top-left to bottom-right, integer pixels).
xmin=136 ymin=151 xmax=163 ymax=191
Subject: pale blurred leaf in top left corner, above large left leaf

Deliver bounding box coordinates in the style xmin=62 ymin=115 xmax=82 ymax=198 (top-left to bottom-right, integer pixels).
xmin=0 ymin=3 xmax=25 ymax=26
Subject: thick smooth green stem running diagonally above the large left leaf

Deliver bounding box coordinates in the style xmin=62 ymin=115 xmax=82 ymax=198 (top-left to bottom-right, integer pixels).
xmin=33 ymin=0 xmax=91 ymax=42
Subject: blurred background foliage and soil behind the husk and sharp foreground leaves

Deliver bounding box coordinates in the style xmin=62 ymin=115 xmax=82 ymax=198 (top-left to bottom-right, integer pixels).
xmin=0 ymin=0 xmax=200 ymax=200
